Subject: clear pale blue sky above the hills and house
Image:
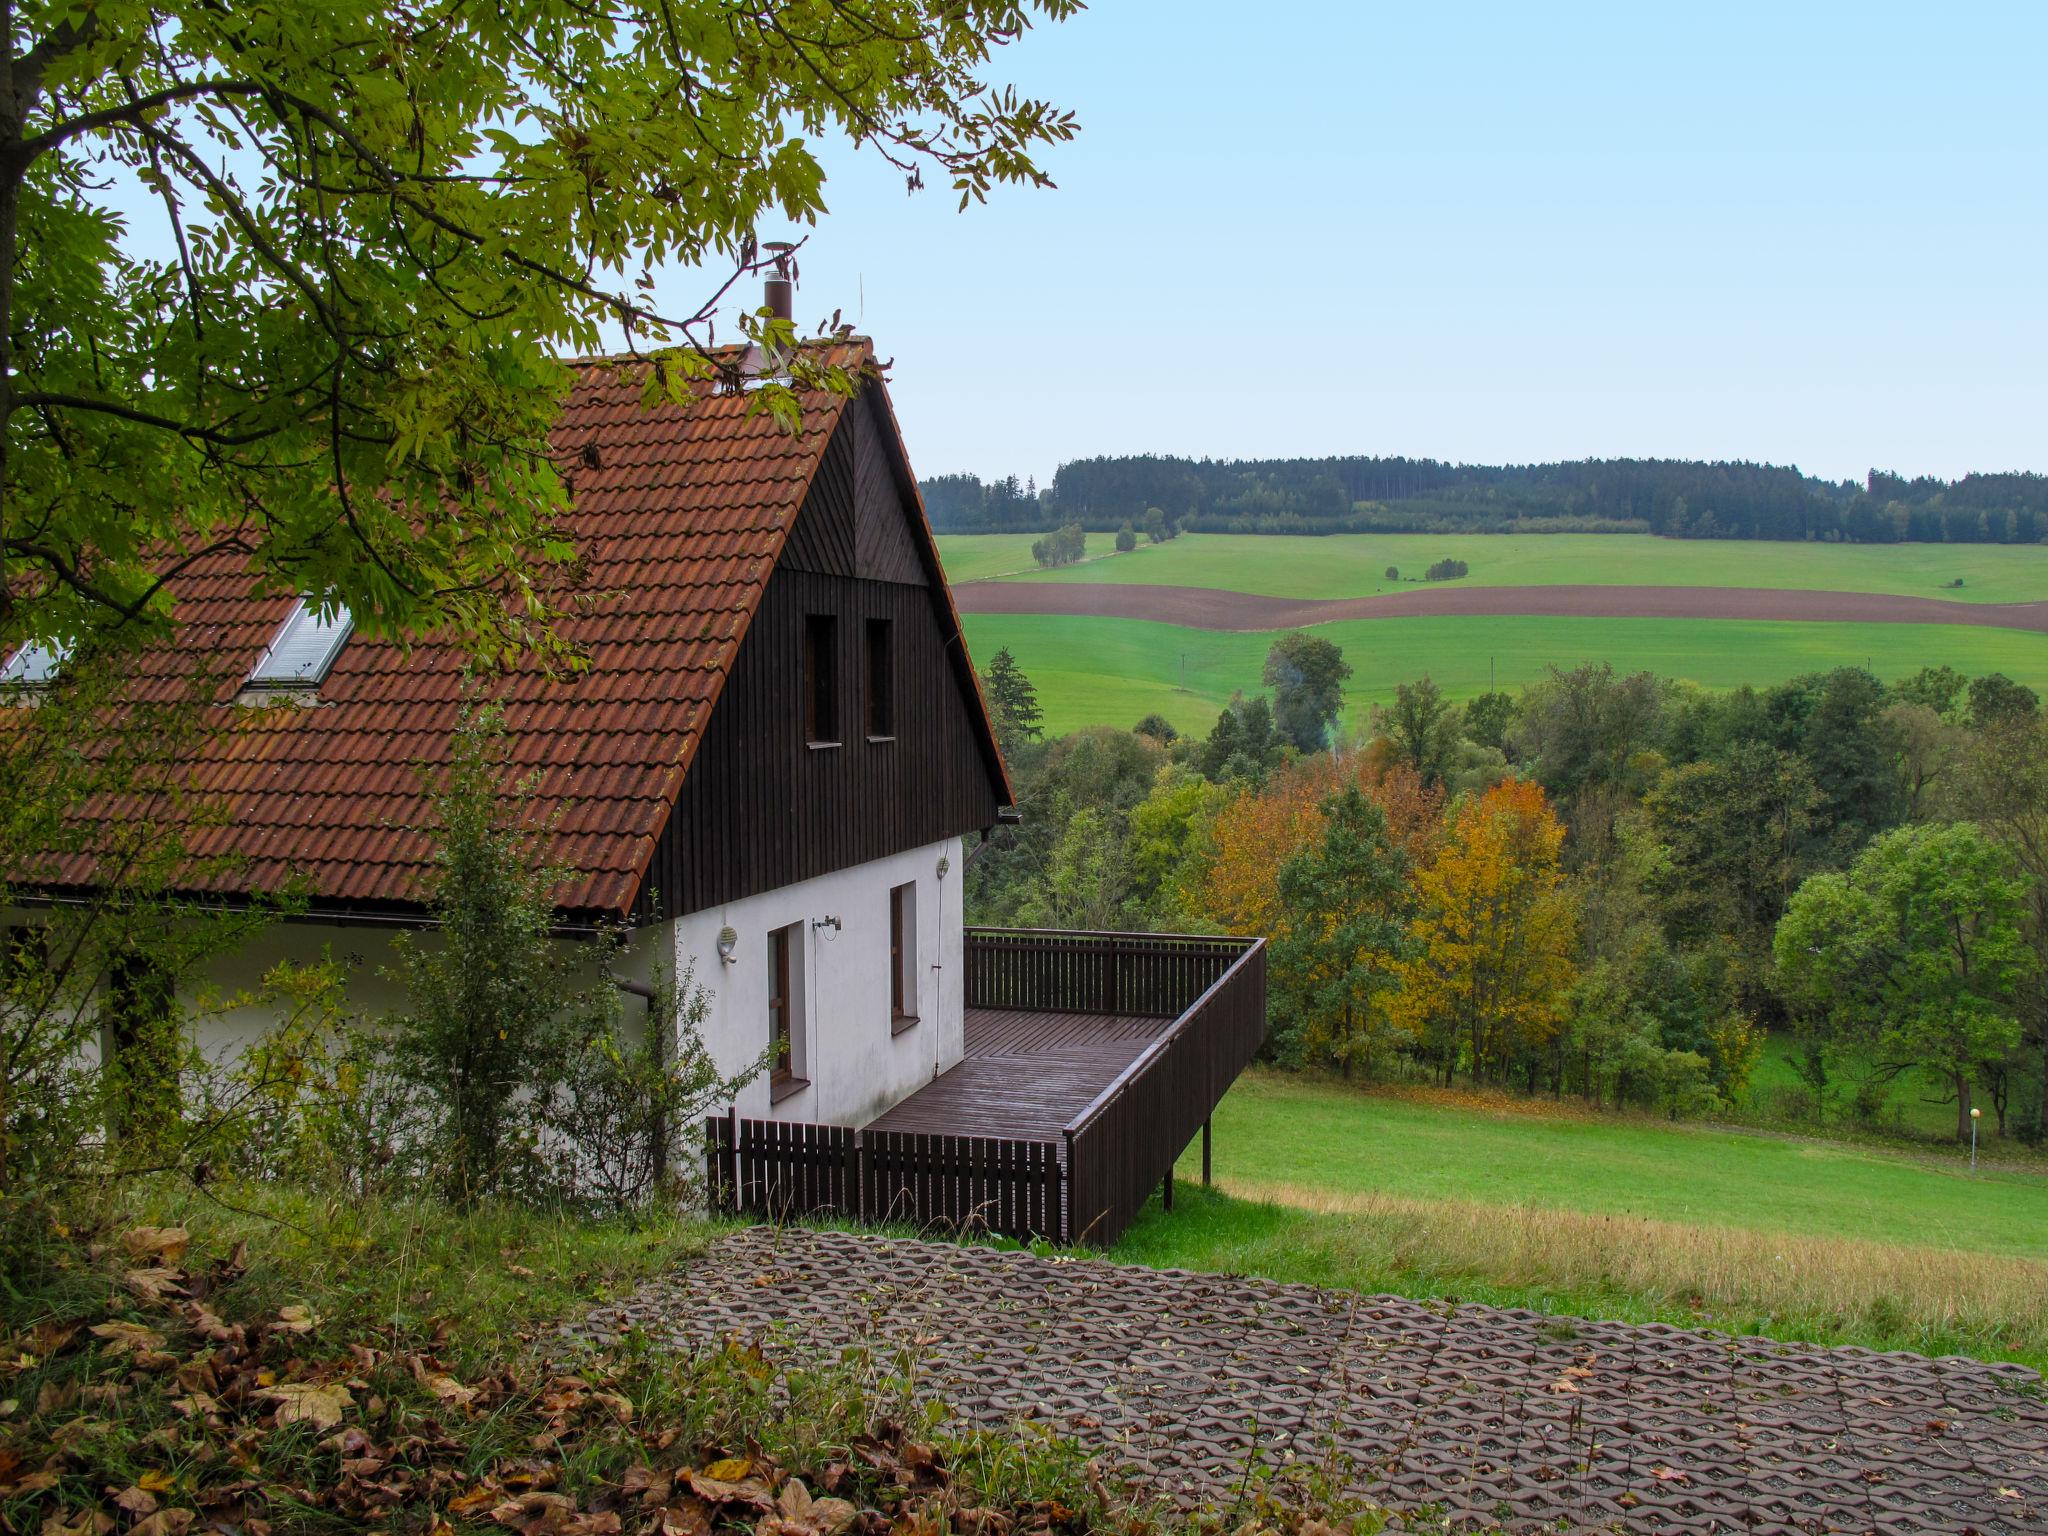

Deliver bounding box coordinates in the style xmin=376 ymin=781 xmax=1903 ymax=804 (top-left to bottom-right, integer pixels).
xmin=674 ymin=0 xmax=2048 ymax=481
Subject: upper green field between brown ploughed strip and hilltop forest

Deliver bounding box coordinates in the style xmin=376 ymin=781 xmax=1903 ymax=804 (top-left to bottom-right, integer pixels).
xmin=938 ymin=532 xmax=2048 ymax=602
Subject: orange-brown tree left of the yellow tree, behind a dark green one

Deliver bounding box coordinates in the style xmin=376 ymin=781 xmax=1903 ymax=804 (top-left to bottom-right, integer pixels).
xmin=1192 ymin=754 xmax=1444 ymax=938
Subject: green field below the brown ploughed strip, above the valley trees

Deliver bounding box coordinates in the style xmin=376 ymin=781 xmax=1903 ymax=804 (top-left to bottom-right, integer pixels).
xmin=965 ymin=606 xmax=2048 ymax=733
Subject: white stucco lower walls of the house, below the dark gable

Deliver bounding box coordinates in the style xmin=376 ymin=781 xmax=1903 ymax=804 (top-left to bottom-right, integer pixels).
xmin=6 ymin=838 xmax=963 ymax=1124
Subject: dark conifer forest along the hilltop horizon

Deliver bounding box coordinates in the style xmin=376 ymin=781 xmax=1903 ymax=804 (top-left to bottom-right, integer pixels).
xmin=922 ymin=455 xmax=2048 ymax=545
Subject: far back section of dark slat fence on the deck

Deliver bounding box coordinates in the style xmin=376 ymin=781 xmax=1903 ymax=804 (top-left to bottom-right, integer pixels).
xmin=965 ymin=928 xmax=1245 ymax=1018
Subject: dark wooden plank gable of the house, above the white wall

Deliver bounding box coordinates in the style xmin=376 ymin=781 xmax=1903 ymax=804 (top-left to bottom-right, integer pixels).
xmin=641 ymin=397 xmax=1001 ymax=915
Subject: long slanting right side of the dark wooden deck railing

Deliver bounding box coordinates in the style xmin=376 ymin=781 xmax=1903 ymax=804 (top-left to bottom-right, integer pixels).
xmin=1065 ymin=938 xmax=1266 ymax=1247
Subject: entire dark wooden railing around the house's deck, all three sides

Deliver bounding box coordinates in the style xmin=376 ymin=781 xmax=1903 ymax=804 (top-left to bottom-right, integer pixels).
xmin=707 ymin=928 xmax=1266 ymax=1247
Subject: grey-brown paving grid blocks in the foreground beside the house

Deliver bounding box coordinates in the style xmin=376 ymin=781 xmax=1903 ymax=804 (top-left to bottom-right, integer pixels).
xmin=571 ymin=1227 xmax=2048 ymax=1536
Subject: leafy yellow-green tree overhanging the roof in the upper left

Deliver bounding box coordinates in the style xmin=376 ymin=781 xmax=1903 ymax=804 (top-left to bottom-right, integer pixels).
xmin=0 ymin=0 xmax=1077 ymax=653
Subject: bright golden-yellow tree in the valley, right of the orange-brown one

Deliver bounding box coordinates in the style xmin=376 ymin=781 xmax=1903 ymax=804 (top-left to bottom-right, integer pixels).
xmin=1386 ymin=778 xmax=1577 ymax=1083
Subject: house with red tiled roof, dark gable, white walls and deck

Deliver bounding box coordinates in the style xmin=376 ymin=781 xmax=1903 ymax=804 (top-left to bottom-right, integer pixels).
xmin=6 ymin=307 xmax=1264 ymax=1231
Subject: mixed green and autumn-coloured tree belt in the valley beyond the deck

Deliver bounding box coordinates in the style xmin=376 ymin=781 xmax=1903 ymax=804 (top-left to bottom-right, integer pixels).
xmin=969 ymin=631 xmax=2048 ymax=1143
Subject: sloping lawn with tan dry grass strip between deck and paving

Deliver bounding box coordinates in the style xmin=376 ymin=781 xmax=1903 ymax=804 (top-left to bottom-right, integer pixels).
xmin=1118 ymin=1073 xmax=2048 ymax=1368
